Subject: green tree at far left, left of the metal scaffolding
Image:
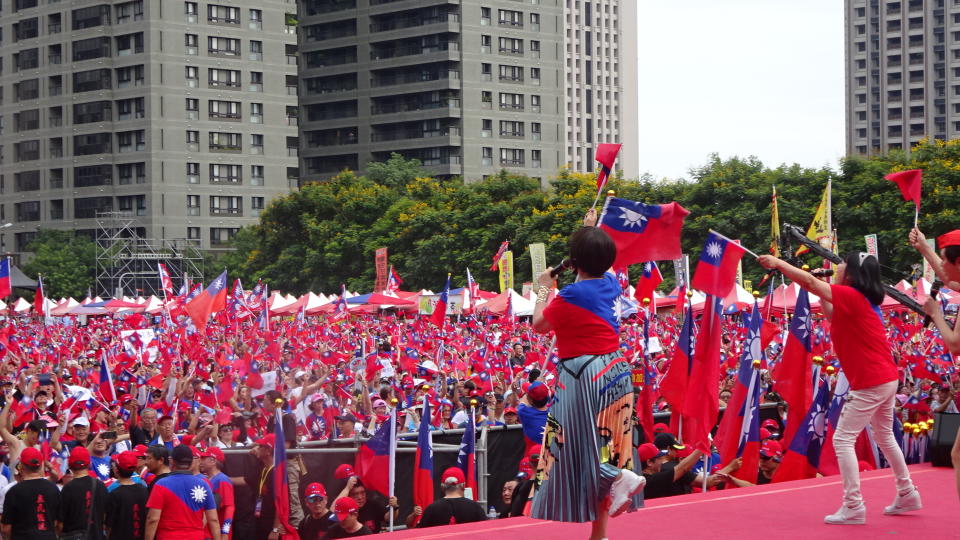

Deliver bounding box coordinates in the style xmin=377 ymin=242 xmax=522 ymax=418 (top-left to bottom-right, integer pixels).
xmin=23 ymin=229 xmax=96 ymax=298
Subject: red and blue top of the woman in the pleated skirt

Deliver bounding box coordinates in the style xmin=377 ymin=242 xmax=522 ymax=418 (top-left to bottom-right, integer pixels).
xmin=543 ymin=273 xmax=623 ymax=358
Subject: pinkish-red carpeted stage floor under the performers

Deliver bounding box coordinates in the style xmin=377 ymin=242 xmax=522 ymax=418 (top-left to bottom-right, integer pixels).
xmin=388 ymin=465 xmax=960 ymax=540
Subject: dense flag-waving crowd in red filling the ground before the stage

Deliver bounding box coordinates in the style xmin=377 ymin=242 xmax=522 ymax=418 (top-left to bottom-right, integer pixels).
xmin=0 ymin=280 xmax=960 ymax=540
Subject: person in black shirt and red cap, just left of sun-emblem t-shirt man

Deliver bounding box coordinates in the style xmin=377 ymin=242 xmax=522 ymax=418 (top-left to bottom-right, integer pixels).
xmin=103 ymin=450 xmax=147 ymax=540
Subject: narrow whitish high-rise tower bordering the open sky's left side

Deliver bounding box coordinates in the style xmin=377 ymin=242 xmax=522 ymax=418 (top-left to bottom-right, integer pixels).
xmin=564 ymin=0 xmax=640 ymax=178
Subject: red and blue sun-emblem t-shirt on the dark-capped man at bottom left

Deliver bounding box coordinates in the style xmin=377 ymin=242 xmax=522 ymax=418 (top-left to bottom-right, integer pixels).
xmin=147 ymin=471 xmax=217 ymax=540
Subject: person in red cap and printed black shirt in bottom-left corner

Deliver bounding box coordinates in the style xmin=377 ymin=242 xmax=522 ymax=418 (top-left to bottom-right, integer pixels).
xmin=0 ymin=447 xmax=60 ymax=540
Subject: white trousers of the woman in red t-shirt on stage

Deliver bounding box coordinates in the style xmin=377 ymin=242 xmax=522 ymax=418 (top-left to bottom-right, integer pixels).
xmin=833 ymin=381 xmax=913 ymax=508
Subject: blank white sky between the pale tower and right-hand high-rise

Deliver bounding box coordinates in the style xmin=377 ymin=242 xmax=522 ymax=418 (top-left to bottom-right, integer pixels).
xmin=637 ymin=0 xmax=844 ymax=178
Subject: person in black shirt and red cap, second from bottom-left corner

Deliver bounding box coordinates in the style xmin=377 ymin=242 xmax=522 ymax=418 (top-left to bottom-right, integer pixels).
xmin=57 ymin=446 xmax=109 ymax=540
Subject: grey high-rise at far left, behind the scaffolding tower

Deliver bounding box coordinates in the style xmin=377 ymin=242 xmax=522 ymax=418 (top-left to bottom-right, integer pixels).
xmin=0 ymin=0 xmax=298 ymax=252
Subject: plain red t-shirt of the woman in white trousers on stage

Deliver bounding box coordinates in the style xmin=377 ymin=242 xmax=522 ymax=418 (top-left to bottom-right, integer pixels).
xmin=830 ymin=285 xmax=899 ymax=390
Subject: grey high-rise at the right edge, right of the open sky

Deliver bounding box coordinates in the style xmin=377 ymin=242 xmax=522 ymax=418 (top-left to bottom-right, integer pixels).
xmin=845 ymin=0 xmax=960 ymax=154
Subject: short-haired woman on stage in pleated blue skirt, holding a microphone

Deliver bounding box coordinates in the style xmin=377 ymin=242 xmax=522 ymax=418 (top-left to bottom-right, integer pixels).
xmin=531 ymin=209 xmax=645 ymax=540
